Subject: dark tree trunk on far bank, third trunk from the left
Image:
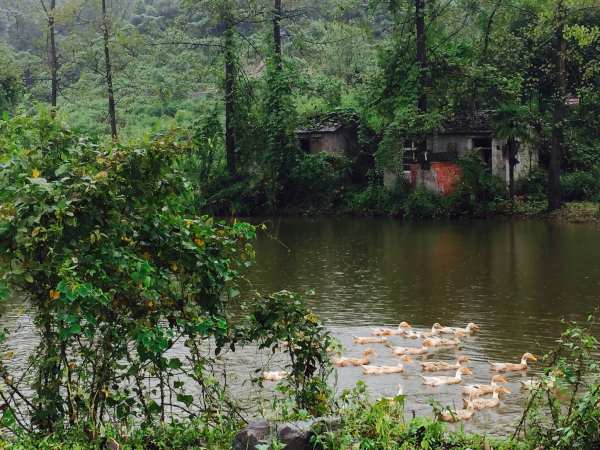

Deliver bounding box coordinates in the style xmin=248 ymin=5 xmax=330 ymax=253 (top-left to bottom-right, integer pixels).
xmin=223 ymin=3 xmax=237 ymax=177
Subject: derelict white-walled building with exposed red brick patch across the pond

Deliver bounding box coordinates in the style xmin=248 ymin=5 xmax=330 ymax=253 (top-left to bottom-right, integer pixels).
xmin=384 ymin=111 xmax=538 ymax=195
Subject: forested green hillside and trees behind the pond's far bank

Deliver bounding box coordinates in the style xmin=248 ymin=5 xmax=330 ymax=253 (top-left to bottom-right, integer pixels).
xmin=0 ymin=0 xmax=600 ymax=216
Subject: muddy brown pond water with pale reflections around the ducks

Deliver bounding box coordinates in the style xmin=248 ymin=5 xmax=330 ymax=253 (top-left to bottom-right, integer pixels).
xmin=0 ymin=218 xmax=600 ymax=434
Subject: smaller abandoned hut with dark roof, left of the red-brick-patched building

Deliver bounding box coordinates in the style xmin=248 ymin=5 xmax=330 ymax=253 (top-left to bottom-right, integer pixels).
xmin=296 ymin=111 xmax=360 ymax=157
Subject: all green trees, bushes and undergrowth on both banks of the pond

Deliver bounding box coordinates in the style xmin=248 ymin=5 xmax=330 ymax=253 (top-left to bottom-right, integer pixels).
xmin=0 ymin=0 xmax=600 ymax=449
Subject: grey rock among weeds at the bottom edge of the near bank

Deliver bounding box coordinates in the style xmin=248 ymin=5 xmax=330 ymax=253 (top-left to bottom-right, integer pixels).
xmin=233 ymin=417 xmax=340 ymax=450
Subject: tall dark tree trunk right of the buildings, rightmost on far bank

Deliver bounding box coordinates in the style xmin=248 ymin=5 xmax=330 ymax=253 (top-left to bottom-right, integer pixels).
xmin=548 ymin=0 xmax=567 ymax=211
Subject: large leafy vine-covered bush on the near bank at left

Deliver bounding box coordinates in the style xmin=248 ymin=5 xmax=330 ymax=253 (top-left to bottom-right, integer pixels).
xmin=0 ymin=110 xmax=328 ymax=436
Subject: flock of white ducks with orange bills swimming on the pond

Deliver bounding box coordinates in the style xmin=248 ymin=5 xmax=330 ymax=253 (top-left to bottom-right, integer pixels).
xmin=263 ymin=322 xmax=537 ymax=422
